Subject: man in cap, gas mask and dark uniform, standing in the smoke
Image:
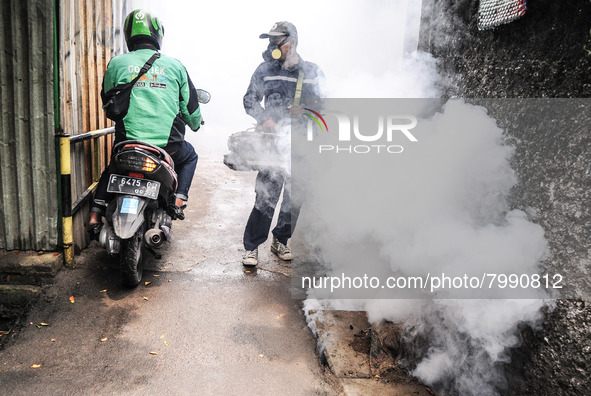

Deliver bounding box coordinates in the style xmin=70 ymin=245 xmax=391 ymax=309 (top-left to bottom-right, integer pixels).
xmin=242 ymin=21 xmax=324 ymax=266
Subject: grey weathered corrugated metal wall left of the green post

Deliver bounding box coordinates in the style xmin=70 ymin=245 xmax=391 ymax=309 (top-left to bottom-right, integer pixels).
xmin=0 ymin=0 xmax=58 ymax=250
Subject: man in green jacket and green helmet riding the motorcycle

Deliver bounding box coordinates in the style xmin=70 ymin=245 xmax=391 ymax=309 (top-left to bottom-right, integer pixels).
xmin=89 ymin=10 xmax=202 ymax=230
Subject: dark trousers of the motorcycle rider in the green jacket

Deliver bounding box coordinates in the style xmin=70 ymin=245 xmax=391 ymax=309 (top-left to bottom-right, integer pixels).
xmin=91 ymin=141 xmax=198 ymax=214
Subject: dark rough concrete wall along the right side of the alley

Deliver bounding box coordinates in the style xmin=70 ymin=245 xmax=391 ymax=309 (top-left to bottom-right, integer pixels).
xmin=420 ymin=0 xmax=591 ymax=395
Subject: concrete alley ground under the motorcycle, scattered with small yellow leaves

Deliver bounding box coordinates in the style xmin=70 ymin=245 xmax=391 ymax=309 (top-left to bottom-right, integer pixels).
xmin=0 ymin=138 xmax=341 ymax=395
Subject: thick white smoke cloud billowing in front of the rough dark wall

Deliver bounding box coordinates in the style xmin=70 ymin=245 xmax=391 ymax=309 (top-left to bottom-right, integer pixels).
xmin=298 ymin=2 xmax=547 ymax=395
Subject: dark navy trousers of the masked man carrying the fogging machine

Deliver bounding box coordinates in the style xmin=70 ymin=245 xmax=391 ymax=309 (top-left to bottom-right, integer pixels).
xmin=243 ymin=170 xmax=301 ymax=250
